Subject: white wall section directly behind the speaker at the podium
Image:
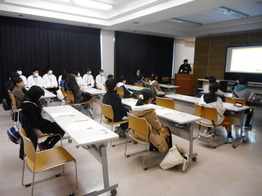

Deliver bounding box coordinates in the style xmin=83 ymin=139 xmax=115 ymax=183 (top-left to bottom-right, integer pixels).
xmin=174 ymin=39 xmax=195 ymax=76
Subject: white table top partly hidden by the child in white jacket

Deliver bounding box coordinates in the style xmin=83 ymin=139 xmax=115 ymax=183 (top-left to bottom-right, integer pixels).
xmin=166 ymin=94 xmax=249 ymax=112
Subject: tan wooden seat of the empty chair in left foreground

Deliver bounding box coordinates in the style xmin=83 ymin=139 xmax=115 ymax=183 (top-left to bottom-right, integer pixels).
xmin=26 ymin=147 xmax=75 ymax=172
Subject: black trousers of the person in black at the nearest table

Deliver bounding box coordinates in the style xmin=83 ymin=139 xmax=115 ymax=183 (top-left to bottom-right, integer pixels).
xmin=40 ymin=122 xmax=65 ymax=149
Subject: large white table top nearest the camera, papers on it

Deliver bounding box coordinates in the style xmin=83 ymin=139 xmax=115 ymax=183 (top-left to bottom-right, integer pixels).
xmin=43 ymin=105 xmax=119 ymax=146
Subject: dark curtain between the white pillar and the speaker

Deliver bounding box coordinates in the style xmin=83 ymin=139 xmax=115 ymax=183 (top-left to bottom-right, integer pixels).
xmin=115 ymin=32 xmax=174 ymax=83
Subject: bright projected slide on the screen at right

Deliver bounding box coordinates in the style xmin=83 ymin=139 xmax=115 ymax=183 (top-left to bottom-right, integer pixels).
xmin=226 ymin=46 xmax=262 ymax=73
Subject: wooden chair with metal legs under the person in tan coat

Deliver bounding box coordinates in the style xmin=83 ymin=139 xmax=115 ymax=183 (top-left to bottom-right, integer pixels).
xmin=125 ymin=113 xmax=157 ymax=170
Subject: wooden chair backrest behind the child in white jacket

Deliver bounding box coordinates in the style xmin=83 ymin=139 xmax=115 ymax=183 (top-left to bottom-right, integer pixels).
xmin=195 ymin=104 xmax=217 ymax=121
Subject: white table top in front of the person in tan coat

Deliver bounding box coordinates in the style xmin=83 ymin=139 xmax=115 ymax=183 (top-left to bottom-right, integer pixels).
xmin=122 ymin=99 xmax=201 ymax=124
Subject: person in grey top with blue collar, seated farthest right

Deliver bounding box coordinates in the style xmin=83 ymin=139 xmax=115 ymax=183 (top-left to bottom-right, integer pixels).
xmin=232 ymin=77 xmax=257 ymax=128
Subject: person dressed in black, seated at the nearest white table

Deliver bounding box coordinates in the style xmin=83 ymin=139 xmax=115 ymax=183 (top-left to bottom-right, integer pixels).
xmin=22 ymin=85 xmax=65 ymax=150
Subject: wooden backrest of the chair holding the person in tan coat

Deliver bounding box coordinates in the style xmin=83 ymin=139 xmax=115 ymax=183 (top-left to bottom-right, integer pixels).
xmin=127 ymin=113 xmax=148 ymax=138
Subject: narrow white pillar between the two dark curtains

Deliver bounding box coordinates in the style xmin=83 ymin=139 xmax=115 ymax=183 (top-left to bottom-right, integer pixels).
xmin=101 ymin=30 xmax=115 ymax=77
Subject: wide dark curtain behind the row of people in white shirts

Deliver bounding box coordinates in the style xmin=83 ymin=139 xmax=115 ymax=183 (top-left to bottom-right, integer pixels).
xmin=0 ymin=17 xmax=101 ymax=100
